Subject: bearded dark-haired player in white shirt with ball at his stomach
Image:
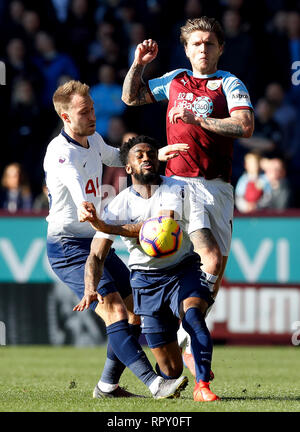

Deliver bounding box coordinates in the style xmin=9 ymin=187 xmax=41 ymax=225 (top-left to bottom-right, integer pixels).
xmin=75 ymin=136 xmax=219 ymax=402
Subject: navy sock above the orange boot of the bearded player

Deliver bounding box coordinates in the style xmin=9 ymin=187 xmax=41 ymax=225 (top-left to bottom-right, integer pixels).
xmin=182 ymin=307 xmax=213 ymax=382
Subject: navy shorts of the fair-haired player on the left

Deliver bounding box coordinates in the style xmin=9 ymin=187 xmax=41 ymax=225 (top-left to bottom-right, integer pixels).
xmin=47 ymin=237 xmax=131 ymax=310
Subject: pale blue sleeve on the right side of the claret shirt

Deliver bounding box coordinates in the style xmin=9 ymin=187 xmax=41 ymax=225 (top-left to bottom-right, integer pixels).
xmin=223 ymin=74 xmax=253 ymax=114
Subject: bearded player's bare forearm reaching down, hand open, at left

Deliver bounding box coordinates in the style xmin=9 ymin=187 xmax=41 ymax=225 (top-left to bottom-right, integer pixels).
xmin=73 ymin=238 xmax=112 ymax=312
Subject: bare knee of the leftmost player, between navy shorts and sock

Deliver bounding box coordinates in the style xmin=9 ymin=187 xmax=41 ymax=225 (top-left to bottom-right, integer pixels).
xmin=95 ymin=291 xmax=128 ymax=326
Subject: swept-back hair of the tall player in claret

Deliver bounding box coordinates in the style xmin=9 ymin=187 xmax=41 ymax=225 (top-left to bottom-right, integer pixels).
xmin=180 ymin=16 xmax=224 ymax=46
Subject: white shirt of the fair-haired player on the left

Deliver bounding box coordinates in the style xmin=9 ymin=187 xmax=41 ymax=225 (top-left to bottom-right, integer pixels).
xmin=44 ymin=130 xmax=122 ymax=237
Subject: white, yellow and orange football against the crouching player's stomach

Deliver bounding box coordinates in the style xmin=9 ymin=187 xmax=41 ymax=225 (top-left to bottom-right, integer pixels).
xmin=139 ymin=216 xmax=182 ymax=258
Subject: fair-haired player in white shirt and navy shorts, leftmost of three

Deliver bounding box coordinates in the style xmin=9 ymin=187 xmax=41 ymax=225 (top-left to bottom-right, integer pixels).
xmin=44 ymin=81 xmax=186 ymax=398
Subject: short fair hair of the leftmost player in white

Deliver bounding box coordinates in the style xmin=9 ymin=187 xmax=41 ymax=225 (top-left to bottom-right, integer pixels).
xmin=52 ymin=80 xmax=90 ymax=116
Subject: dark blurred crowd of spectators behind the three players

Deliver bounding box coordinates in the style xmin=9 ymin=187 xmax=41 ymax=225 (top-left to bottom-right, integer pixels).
xmin=0 ymin=0 xmax=300 ymax=213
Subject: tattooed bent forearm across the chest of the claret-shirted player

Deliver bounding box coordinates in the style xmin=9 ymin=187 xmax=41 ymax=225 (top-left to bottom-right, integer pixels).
xmin=169 ymin=107 xmax=254 ymax=138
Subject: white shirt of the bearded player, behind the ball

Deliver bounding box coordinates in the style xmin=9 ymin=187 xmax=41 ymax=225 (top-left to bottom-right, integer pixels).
xmin=95 ymin=176 xmax=195 ymax=270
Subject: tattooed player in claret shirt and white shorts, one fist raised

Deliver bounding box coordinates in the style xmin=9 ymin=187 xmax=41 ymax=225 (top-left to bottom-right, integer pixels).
xmin=122 ymin=16 xmax=254 ymax=371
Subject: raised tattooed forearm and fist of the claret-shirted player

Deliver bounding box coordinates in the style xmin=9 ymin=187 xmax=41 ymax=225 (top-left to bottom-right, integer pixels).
xmin=122 ymin=39 xmax=158 ymax=106
